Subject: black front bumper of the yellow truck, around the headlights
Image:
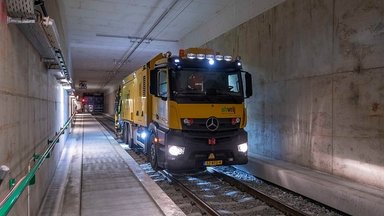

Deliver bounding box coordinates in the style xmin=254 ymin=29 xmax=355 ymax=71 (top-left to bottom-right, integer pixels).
xmin=164 ymin=129 xmax=248 ymax=171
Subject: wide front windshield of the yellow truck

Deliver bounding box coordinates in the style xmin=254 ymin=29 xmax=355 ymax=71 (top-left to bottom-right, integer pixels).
xmin=171 ymin=70 xmax=243 ymax=103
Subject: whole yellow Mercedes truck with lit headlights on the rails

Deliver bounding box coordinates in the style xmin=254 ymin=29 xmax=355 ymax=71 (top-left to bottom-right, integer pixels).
xmin=115 ymin=48 xmax=252 ymax=171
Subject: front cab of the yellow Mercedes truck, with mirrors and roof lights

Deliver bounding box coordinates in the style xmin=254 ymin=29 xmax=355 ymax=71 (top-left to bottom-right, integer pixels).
xmin=147 ymin=48 xmax=252 ymax=170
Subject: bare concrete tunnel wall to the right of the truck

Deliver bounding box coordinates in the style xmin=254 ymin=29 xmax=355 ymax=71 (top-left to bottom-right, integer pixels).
xmin=203 ymin=0 xmax=384 ymax=188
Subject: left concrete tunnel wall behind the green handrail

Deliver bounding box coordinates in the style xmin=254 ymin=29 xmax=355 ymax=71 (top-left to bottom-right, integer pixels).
xmin=0 ymin=0 xmax=69 ymax=215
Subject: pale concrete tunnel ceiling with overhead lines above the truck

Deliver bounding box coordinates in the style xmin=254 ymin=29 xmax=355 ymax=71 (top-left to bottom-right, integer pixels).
xmin=59 ymin=0 xmax=284 ymax=92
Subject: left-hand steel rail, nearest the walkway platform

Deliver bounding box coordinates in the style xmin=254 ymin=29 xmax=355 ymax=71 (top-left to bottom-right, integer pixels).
xmin=158 ymin=170 xmax=220 ymax=216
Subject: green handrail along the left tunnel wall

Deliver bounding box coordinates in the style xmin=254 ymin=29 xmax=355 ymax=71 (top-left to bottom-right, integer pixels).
xmin=0 ymin=114 xmax=75 ymax=216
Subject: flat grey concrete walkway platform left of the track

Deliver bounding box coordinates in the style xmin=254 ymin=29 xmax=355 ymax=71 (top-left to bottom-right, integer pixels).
xmin=39 ymin=114 xmax=185 ymax=216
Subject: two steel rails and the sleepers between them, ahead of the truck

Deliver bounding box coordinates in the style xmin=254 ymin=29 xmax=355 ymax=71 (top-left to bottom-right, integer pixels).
xmin=163 ymin=169 xmax=308 ymax=216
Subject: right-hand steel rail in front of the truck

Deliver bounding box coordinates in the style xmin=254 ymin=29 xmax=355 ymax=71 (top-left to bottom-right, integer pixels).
xmin=209 ymin=169 xmax=308 ymax=216
